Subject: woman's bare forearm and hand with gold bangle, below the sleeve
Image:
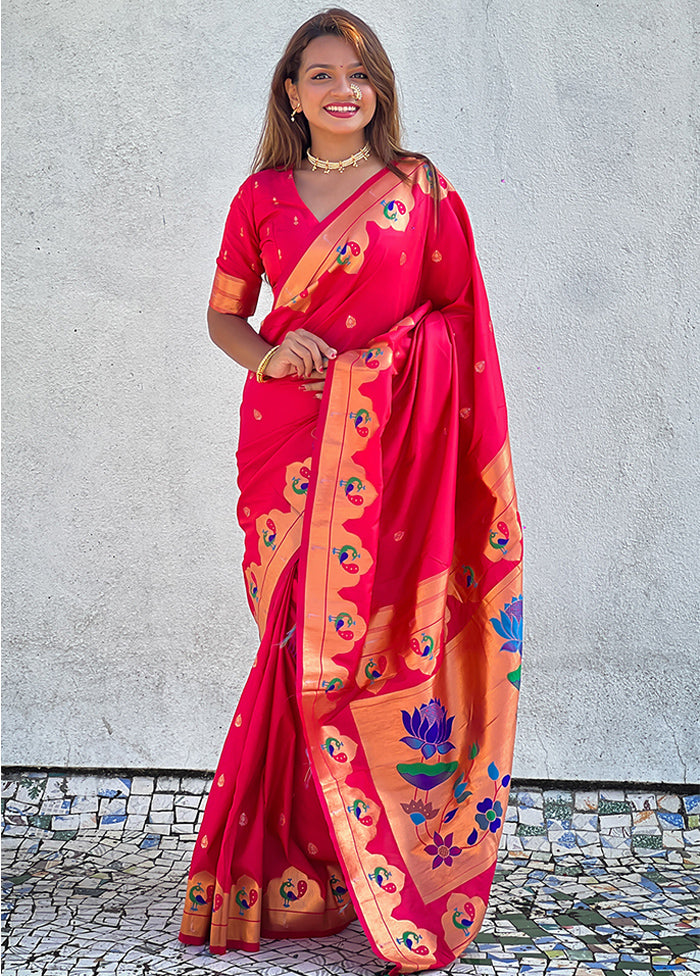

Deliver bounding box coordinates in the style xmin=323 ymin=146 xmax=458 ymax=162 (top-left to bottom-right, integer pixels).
xmin=207 ymin=307 xmax=336 ymax=379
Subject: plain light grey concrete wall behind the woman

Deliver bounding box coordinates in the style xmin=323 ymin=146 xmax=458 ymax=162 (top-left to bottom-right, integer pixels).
xmin=3 ymin=0 xmax=700 ymax=783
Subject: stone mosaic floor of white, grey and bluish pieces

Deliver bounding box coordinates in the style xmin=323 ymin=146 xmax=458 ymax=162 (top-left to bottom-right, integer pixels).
xmin=2 ymin=773 xmax=700 ymax=976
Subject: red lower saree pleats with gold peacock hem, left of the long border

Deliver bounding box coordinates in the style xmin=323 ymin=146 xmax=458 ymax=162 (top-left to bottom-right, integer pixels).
xmin=180 ymin=562 xmax=355 ymax=952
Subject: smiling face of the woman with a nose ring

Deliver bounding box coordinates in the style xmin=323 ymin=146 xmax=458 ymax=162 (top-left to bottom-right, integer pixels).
xmin=286 ymin=34 xmax=377 ymax=140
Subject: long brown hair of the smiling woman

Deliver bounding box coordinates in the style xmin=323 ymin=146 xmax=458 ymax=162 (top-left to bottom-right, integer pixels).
xmin=253 ymin=7 xmax=439 ymax=200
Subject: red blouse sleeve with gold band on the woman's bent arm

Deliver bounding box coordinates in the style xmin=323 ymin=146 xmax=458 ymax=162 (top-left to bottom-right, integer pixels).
xmin=209 ymin=179 xmax=263 ymax=319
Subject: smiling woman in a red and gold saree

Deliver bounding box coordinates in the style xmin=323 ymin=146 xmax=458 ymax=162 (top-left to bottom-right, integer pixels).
xmin=180 ymin=10 xmax=522 ymax=973
